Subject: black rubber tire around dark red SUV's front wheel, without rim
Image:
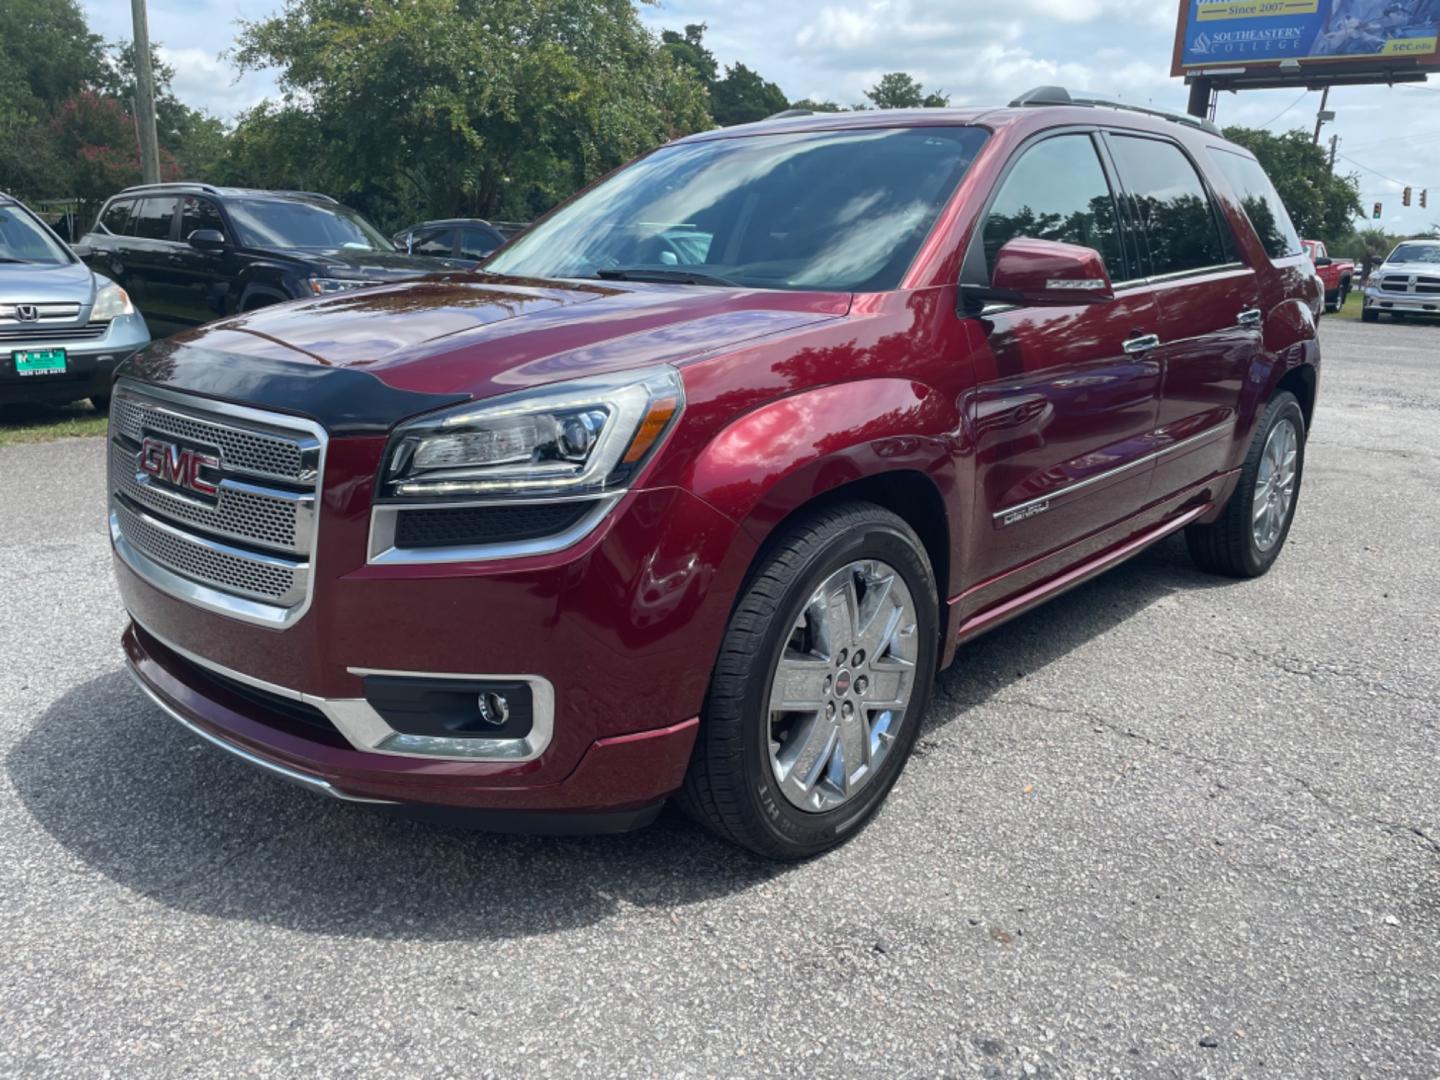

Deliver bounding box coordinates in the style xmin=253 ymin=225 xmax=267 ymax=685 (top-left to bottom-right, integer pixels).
xmin=678 ymin=503 xmax=939 ymax=860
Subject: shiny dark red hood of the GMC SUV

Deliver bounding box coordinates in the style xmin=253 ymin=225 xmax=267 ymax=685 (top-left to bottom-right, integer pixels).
xmin=131 ymin=274 xmax=851 ymax=426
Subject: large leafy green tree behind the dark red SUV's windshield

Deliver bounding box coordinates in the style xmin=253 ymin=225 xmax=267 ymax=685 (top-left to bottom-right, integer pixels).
xmin=226 ymin=0 xmax=710 ymax=223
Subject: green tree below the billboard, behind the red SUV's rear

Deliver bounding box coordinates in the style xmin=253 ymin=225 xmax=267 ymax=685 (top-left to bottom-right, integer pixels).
xmin=1225 ymin=127 xmax=1361 ymax=248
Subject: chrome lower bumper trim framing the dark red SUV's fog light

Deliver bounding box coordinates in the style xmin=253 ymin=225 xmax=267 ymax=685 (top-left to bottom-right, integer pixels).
xmin=130 ymin=613 xmax=554 ymax=763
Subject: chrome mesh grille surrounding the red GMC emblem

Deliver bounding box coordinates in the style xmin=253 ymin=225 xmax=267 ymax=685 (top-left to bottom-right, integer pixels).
xmin=109 ymin=380 xmax=325 ymax=628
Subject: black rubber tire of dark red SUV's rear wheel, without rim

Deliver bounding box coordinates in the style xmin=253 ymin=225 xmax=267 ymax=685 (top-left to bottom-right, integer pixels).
xmin=1185 ymin=390 xmax=1306 ymax=577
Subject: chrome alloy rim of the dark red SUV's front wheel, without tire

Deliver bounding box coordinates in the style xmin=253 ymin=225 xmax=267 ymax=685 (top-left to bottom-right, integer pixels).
xmin=768 ymin=559 xmax=920 ymax=812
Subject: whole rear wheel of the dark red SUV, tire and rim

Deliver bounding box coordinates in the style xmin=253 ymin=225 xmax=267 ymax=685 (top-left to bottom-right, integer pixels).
xmin=1185 ymin=390 xmax=1305 ymax=577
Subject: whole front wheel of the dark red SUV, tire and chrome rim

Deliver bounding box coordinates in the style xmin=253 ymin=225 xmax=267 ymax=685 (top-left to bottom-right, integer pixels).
xmin=680 ymin=503 xmax=939 ymax=860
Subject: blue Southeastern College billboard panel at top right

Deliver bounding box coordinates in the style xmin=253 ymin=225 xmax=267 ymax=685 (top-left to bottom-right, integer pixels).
xmin=1172 ymin=0 xmax=1440 ymax=78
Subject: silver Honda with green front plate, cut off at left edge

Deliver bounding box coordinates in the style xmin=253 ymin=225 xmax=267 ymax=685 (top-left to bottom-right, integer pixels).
xmin=0 ymin=192 xmax=150 ymax=412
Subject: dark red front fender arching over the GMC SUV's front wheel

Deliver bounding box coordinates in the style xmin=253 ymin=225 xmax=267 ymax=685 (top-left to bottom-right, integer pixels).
xmin=684 ymin=379 xmax=963 ymax=552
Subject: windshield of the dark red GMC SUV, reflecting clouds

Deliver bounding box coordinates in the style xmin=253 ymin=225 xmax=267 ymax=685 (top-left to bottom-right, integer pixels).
xmin=485 ymin=127 xmax=986 ymax=292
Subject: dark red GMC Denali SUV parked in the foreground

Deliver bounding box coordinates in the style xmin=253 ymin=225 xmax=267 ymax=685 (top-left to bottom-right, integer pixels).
xmin=118 ymin=88 xmax=1320 ymax=858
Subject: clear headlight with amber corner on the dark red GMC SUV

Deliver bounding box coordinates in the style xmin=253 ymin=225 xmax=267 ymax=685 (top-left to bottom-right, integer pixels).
xmin=380 ymin=367 xmax=684 ymax=500
